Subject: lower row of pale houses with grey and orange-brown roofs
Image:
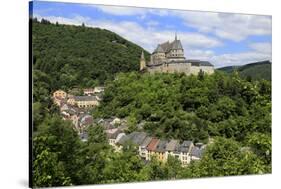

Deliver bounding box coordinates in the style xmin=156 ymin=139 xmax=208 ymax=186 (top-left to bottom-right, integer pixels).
xmin=105 ymin=128 xmax=206 ymax=166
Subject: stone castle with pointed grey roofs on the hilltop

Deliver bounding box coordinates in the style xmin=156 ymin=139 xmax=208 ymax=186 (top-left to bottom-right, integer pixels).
xmin=140 ymin=35 xmax=214 ymax=75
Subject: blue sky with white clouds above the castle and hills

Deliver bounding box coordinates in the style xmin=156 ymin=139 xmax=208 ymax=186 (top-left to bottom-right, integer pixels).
xmin=31 ymin=1 xmax=272 ymax=68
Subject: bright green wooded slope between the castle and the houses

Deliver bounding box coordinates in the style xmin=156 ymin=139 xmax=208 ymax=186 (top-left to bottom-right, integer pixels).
xmin=94 ymin=72 xmax=271 ymax=142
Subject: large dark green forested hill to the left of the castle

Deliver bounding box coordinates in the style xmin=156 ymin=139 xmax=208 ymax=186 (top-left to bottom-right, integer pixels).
xmin=31 ymin=19 xmax=149 ymax=90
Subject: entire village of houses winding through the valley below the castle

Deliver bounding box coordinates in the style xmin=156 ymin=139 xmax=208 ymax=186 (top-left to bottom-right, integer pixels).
xmin=53 ymin=87 xmax=206 ymax=166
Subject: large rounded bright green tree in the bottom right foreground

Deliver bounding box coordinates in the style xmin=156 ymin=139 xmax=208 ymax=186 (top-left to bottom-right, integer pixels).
xmin=183 ymin=137 xmax=266 ymax=177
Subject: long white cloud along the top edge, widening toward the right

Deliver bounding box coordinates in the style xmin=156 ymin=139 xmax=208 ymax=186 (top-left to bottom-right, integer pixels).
xmin=87 ymin=5 xmax=271 ymax=42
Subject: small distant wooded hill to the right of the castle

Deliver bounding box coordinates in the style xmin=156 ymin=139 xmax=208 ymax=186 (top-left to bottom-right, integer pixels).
xmin=218 ymin=61 xmax=271 ymax=81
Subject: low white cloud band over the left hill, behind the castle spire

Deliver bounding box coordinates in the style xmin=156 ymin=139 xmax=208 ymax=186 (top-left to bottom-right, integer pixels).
xmin=35 ymin=15 xmax=222 ymax=52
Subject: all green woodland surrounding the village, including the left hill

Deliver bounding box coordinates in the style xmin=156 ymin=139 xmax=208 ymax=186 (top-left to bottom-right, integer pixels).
xmin=32 ymin=20 xmax=271 ymax=187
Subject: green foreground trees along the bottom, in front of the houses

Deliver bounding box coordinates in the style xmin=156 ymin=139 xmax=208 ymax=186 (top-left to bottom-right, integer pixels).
xmin=33 ymin=116 xmax=271 ymax=187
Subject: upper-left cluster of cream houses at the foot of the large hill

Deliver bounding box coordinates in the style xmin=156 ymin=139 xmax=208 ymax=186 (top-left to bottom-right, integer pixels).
xmin=53 ymin=87 xmax=104 ymax=133
